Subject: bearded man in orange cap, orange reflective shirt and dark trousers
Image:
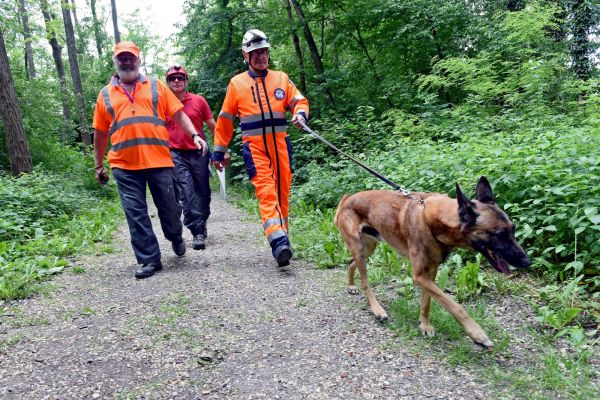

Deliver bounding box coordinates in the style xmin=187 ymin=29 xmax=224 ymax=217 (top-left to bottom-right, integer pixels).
xmin=94 ymin=42 xmax=208 ymax=279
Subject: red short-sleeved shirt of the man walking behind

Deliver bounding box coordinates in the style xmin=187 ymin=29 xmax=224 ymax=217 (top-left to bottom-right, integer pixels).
xmin=167 ymin=92 xmax=213 ymax=150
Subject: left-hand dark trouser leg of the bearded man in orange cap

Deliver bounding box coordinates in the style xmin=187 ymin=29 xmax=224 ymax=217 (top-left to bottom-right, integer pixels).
xmin=112 ymin=168 xmax=160 ymax=264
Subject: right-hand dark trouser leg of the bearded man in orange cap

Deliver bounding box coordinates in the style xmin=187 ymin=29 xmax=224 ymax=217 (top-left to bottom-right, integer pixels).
xmin=144 ymin=168 xmax=183 ymax=242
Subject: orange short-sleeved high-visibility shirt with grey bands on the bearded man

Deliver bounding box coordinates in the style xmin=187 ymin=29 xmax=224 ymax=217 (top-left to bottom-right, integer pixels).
xmin=94 ymin=75 xmax=183 ymax=170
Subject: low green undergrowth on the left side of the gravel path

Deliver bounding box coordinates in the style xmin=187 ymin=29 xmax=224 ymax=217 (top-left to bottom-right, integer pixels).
xmin=0 ymin=168 xmax=120 ymax=300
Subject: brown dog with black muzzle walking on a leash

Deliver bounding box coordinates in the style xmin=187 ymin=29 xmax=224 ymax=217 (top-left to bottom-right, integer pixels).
xmin=334 ymin=176 xmax=531 ymax=349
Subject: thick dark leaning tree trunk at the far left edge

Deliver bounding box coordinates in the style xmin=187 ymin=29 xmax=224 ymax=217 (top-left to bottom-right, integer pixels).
xmin=0 ymin=29 xmax=32 ymax=176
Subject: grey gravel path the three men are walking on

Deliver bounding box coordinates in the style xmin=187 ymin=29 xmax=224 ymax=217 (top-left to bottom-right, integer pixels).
xmin=0 ymin=196 xmax=494 ymax=400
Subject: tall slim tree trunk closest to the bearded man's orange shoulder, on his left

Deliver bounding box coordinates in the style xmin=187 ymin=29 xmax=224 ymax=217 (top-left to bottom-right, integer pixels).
xmin=60 ymin=1 xmax=91 ymax=145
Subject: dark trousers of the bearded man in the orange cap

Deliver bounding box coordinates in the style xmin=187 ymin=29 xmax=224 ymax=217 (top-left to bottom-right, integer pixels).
xmin=112 ymin=168 xmax=183 ymax=264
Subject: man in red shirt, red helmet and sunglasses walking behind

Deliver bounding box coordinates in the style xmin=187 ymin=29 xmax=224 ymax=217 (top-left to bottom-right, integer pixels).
xmin=166 ymin=65 xmax=215 ymax=250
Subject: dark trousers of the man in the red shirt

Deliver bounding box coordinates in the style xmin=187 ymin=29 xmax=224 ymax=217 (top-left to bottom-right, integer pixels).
xmin=171 ymin=150 xmax=211 ymax=236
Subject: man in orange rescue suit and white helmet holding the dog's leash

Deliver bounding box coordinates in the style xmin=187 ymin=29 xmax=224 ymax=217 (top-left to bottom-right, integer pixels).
xmin=212 ymin=29 xmax=309 ymax=267
